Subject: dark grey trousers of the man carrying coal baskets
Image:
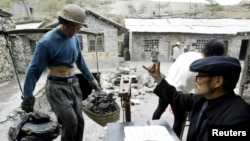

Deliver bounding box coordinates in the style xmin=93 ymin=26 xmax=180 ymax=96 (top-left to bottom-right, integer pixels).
xmin=45 ymin=80 xmax=84 ymax=141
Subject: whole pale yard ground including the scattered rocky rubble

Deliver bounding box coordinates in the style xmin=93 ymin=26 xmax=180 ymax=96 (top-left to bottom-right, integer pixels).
xmin=0 ymin=61 xmax=178 ymax=141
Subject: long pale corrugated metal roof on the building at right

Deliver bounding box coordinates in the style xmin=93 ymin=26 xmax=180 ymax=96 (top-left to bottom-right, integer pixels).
xmin=125 ymin=18 xmax=250 ymax=34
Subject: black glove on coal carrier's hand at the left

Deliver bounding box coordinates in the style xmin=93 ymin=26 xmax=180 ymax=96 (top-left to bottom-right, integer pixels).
xmin=21 ymin=97 xmax=35 ymax=113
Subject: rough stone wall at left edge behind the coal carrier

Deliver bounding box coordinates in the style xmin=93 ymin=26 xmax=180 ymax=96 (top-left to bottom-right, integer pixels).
xmin=0 ymin=14 xmax=43 ymax=86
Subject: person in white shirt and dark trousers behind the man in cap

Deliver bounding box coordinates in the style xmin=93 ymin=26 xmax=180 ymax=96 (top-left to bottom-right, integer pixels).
xmin=152 ymin=39 xmax=225 ymax=137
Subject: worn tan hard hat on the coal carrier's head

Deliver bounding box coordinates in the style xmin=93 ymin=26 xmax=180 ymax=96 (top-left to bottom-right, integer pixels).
xmin=58 ymin=4 xmax=87 ymax=26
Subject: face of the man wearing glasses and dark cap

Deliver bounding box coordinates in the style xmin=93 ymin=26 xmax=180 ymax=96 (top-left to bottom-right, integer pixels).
xmin=194 ymin=73 xmax=215 ymax=96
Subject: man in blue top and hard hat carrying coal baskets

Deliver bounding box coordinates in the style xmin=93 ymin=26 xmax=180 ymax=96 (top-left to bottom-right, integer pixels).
xmin=21 ymin=4 xmax=100 ymax=141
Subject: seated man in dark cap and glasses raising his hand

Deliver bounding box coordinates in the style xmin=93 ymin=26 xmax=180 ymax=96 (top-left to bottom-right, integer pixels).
xmin=143 ymin=56 xmax=250 ymax=141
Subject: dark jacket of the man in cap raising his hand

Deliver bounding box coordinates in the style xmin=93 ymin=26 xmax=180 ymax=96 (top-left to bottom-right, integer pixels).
xmin=154 ymin=80 xmax=250 ymax=141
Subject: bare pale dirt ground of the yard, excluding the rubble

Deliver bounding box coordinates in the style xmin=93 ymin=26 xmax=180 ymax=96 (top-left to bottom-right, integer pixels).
xmin=0 ymin=57 xmax=243 ymax=141
